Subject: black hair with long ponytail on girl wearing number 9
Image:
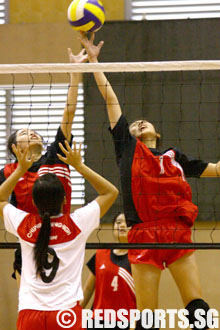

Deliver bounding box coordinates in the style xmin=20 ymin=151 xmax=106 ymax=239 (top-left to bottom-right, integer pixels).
xmin=32 ymin=173 xmax=65 ymax=274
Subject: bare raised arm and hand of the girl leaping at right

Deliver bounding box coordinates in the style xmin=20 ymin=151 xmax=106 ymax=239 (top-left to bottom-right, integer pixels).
xmin=79 ymin=32 xmax=121 ymax=129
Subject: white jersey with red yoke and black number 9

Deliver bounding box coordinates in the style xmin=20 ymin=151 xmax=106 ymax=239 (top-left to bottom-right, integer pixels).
xmin=3 ymin=201 xmax=100 ymax=311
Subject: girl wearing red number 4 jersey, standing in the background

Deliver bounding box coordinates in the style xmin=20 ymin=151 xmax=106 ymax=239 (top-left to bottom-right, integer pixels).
xmin=82 ymin=213 xmax=136 ymax=329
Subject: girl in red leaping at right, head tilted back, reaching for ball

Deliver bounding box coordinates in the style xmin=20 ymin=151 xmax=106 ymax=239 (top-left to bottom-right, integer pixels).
xmin=80 ymin=33 xmax=220 ymax=329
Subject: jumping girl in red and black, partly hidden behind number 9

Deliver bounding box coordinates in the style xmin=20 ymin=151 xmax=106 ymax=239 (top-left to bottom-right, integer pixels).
xmin=0 ymin=48 xmax=88 ymax=282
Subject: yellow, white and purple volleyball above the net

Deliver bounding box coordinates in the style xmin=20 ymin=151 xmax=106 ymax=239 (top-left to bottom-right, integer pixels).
xmin=67 ymin=0 xmax=105 ymax=32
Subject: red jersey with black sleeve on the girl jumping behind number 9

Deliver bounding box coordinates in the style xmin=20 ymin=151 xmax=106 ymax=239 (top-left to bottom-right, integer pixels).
xmin=0 ymin=128 xmax=71 ymax=213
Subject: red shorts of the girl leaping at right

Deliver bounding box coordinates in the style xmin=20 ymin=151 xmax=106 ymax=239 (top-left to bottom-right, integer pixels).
xmin=128 ymin=220 xmax=194 ymax=269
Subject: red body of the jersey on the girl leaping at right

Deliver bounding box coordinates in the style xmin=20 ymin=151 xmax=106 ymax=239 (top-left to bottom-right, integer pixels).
xmin=131 ymin=140 xmax=198 ymax=226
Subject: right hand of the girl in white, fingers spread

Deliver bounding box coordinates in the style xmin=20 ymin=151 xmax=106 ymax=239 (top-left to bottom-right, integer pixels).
xmin=57 ymin=141 xmax=82 ymax=169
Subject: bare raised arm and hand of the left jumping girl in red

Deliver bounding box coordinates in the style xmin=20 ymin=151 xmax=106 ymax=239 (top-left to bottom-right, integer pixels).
xmin=61 ymin=48 xmax=88 ymax=141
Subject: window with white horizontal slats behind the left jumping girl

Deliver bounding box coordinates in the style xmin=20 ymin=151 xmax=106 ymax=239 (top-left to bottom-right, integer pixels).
xmin=0 ymin=85 xmax=85 ymax=205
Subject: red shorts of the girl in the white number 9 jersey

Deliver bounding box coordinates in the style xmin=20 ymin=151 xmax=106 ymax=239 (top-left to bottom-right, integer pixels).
xmin=17 ymin=304 xmax=83 ymax=330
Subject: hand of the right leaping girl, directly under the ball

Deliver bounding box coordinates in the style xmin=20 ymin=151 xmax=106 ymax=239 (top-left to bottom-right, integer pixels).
xmin=79 ymin=32 xmax=104 ymax=62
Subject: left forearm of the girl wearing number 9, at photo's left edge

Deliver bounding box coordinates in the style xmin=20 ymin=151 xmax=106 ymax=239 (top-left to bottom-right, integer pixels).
xmin=0 ymin=166 xmax=25 ymax=202
